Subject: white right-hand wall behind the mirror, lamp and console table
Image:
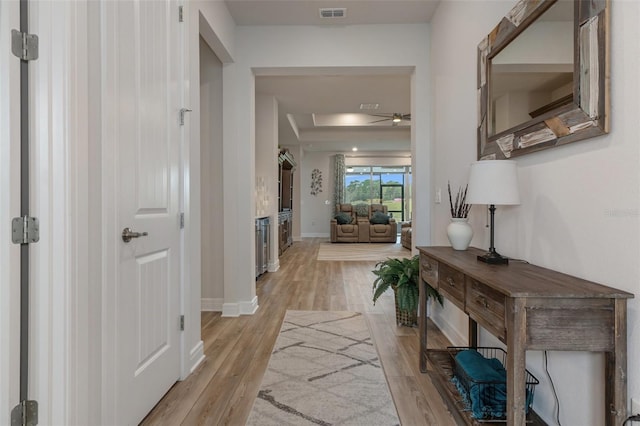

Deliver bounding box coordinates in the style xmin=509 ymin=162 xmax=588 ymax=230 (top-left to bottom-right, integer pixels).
xmin=430 ymin=0 xmax=640 ymax=426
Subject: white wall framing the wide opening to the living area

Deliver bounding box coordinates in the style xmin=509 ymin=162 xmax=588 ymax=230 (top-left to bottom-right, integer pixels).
xmin=224 ymin=24 xmax=430 ymax=306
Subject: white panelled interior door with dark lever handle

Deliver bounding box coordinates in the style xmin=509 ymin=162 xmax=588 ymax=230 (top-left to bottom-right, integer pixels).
xmin=102 ymin=0 xmax=182 ymax=424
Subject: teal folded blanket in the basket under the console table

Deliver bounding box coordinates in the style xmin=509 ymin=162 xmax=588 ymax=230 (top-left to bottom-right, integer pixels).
xmin=453 ymin=350 xmax=532 ymax=419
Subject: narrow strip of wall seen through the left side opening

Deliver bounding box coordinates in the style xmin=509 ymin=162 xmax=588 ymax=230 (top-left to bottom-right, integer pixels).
xmin=199 ymin=38 xmax=225 ymax=311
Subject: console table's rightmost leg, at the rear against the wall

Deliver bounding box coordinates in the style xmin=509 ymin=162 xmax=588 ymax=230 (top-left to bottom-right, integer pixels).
xmin=604 ymin=299 xmax=627 ymax=426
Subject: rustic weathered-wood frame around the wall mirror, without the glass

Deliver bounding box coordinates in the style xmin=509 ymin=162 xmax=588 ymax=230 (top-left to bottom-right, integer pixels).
xmin=478 ymin=0 xmax=610 ymax=159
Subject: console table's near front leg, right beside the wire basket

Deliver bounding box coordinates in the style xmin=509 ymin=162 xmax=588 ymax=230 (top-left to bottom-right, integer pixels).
xmin=506 ymin=298 xmax=527 ymax=426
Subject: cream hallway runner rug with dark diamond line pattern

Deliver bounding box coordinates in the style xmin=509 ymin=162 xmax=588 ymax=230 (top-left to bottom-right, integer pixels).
xmin=247 ymin=311 xmax=400 ymax=426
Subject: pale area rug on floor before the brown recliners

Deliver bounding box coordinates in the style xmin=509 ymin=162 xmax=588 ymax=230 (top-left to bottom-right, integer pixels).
xmin=317 ymin=243 xmax=411 ymax=261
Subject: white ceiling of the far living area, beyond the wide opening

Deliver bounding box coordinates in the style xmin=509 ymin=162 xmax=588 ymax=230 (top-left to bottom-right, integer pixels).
xmin=256 ymin=70 xmax=411 ymax=152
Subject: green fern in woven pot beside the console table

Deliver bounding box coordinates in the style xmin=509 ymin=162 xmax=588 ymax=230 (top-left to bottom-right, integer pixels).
xmin=372 ymin=255 xmax=442 ymax=326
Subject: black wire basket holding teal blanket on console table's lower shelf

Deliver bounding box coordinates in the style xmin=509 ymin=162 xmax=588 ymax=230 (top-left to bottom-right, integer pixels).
xmin=447 ymin=346 xmax=540 ymax=421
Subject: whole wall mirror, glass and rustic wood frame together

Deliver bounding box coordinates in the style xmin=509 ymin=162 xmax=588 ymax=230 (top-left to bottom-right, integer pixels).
xmin=478 ymin=0 xmax=609 ymax=159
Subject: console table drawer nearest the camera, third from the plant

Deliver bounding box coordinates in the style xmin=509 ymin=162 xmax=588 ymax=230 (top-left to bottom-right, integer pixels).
xmin=466 ymin=277 xmax=507 ymax=341
